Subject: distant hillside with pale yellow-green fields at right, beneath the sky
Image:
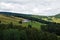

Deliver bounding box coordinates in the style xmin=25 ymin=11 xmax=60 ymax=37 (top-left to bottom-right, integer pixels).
xmin=32 ymin=14 xmax=60 ymax=23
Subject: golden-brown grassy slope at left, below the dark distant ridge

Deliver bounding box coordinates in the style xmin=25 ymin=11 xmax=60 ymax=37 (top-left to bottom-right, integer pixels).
xmin=0 ymin=15 xmax=22 ymax=24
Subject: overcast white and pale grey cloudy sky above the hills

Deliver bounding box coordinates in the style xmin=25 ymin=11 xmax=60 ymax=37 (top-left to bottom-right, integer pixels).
xmin=0 ymin=0 xmax=60 ymax=15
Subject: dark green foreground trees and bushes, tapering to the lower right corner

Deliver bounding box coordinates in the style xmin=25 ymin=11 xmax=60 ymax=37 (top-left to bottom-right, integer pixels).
xmin=0 ymin=23 xmax=59 ymax=40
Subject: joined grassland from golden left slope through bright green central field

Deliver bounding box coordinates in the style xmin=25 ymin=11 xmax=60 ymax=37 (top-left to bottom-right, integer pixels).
xmin=0 ymin=14 xmax=41 ymax=29
